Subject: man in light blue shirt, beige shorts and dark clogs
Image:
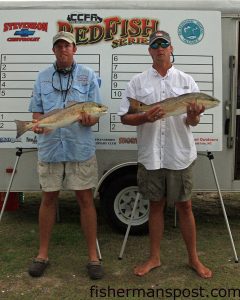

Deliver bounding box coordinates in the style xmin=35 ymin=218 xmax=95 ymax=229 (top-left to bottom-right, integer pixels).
xmin=29 ymin=31 xmax=103 ymax=279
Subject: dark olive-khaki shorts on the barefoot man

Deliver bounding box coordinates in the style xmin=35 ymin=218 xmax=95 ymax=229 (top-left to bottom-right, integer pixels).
xmin=137 ymin=162 xmax=194 ymax=206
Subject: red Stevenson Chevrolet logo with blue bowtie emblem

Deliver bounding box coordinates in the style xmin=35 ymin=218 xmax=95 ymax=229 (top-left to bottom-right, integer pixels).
xmin=3 ymin=22 xmax=48 ymax=42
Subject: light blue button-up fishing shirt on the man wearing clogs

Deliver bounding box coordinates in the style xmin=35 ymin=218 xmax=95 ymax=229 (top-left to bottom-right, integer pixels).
xmin=29 ymin=64 xmax=101 ymax=162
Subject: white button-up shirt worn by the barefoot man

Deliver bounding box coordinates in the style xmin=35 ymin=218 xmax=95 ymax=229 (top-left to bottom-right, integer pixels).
xmin=118 ymin=66 xmax=199 ymax=170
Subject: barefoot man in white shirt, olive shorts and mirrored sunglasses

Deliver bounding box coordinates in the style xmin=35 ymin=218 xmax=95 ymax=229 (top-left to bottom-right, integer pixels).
xmin=119 ymin=31 xmax=212 ymax=278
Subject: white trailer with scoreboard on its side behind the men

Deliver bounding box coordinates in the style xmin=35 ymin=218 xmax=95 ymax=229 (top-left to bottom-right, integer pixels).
xmin=0 ymin=0 xmax=240 ymax=233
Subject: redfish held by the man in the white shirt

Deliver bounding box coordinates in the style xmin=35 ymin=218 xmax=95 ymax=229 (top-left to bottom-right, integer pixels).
xmin=128 ymin=93 xmax=220 ymax=117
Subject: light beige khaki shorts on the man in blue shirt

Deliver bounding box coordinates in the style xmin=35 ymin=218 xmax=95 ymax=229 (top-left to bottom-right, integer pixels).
xmin=38 ymin=155 xmax=98 ymax=192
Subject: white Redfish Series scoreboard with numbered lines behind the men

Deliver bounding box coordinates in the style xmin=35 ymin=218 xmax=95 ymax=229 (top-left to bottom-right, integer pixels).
xmin=0 ymin=9 xmax=222 ymax=151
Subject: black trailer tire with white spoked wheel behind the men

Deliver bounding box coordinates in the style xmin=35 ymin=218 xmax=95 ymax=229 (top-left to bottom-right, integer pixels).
xmin=100 ymin=173 xmax=149 ymax=235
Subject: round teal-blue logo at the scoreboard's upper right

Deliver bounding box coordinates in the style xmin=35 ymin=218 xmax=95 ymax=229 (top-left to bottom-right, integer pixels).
xmin=178 ymin=19 xmax=204 ymax=45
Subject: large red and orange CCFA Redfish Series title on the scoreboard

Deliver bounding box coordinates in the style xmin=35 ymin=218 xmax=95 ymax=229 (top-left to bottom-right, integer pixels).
xmin=57 ymin=14 xmax=159 ymax=48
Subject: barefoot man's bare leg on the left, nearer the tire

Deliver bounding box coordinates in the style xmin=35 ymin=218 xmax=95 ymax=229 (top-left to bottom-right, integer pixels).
xmin=134 ymin=200 xmax=165 ymax=276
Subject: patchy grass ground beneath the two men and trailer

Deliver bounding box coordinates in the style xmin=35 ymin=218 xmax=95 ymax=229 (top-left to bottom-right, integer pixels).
xmin=0 ymin=193 xmax=240 ymax=300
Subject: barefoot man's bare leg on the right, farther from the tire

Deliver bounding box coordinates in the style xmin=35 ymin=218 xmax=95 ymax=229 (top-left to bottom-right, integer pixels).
xmin=176 ymin=200 xmax=212 ymax=278
